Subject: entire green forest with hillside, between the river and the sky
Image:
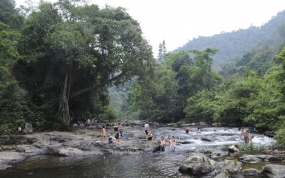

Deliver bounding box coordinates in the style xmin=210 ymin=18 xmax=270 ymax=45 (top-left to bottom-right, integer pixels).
xmin=0 ymin=0 xmax=285 ymax=144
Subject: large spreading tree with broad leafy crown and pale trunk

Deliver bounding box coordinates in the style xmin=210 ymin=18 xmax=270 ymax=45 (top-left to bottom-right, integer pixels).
xmin=17 ymin=0 xmax=154 ymax=124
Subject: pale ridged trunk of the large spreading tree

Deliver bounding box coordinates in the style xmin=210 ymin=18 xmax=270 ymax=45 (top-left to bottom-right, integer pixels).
xmin=59 ymin=72 xmax=70 ymax=126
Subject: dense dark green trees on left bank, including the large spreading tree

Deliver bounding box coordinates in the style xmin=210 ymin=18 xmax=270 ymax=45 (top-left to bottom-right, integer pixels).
xmin=0 ymin=0 xmax=154 ymax=133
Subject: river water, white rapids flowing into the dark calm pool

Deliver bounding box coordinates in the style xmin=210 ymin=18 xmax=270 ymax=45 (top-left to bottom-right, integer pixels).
xmin=0 ymin=127 xmax=275 ymax=178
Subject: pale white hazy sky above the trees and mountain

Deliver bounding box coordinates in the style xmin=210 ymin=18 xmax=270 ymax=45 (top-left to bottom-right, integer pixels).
xmin=15 ymin=0 xmax=285 ymax=57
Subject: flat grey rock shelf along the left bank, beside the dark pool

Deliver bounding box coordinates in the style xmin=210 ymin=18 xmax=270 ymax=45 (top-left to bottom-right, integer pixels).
xmin=0 ymin=127 xmax=157 ymax=170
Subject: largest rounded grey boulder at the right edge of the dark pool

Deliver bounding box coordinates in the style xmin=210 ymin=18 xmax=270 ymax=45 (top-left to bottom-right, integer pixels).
xmin=179 ymin=153 xmax=216 ymax=175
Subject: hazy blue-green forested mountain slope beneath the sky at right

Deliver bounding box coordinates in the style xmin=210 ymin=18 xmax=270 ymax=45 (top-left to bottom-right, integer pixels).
xmin=173 ymin=11 xmax=285 ymax=66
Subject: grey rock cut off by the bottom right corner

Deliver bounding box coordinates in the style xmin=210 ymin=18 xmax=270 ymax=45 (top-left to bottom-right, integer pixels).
xmin=261 ymin=164 xmax=285 ymax=178
